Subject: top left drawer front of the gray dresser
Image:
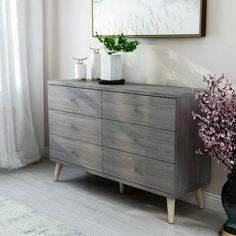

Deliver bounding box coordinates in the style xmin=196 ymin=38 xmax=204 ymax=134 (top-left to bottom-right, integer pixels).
xmin=48 ymin=85 xmax=102 ymax=117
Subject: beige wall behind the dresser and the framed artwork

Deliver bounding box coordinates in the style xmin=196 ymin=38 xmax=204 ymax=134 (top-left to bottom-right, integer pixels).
xmin=44 ymin=0 xmax=236 ymax=194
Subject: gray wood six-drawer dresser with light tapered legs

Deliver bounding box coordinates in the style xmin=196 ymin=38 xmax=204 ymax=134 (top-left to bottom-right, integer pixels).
xmin=48 ymin=80 xmax=209 ymax=223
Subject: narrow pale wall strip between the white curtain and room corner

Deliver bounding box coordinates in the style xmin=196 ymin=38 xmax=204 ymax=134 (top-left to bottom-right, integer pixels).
xmin=26 ymin=0 xmax=44 ymax=151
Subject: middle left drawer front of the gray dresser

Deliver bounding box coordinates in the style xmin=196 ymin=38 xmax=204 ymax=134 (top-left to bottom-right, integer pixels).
xmin=49 ymin=110 xmax=102 ymax=145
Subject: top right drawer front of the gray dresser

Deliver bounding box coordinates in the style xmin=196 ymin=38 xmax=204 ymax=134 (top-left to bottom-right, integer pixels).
xmin=103 ymin=92 xmax=176 ymax=131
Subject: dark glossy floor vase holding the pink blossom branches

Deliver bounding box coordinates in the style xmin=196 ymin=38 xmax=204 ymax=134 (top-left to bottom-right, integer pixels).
xmin=221 ymin=174 xmax=236 ymax=235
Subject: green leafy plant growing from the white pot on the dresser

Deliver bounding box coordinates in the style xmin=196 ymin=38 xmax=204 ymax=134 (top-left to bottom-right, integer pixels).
xmin=96 ymin=33 xmax=140 ymax=55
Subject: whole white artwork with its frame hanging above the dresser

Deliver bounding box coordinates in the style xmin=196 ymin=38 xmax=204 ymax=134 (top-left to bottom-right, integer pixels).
xmin=92 ymin=0 xmax=206 ymax=37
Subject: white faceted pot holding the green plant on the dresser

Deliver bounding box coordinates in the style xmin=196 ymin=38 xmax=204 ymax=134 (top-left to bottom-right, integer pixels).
xmin=101 ymin=54 xmax=122 ymax=81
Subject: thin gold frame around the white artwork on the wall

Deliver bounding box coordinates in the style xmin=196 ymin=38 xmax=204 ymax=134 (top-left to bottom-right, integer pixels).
xmin=91 ymin=0 xmax=207 ymax=38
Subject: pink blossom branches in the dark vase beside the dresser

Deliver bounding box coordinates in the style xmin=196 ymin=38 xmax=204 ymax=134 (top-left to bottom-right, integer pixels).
xmin=192 ymin=75 xmax=236 ymax=177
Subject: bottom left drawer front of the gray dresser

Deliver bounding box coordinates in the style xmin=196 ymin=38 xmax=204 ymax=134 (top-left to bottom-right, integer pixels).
xmin=50 ymin=135 xmax=102 ymax=172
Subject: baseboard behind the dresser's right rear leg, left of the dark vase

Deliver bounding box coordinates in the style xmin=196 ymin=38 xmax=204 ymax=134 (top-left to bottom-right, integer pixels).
xmin=180 ymin=192 xmax=224 ymax=213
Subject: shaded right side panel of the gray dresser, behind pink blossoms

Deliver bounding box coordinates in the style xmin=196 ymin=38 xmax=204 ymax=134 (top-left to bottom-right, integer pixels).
xmin=175 ymin=97 xmax=210 ymax=196
